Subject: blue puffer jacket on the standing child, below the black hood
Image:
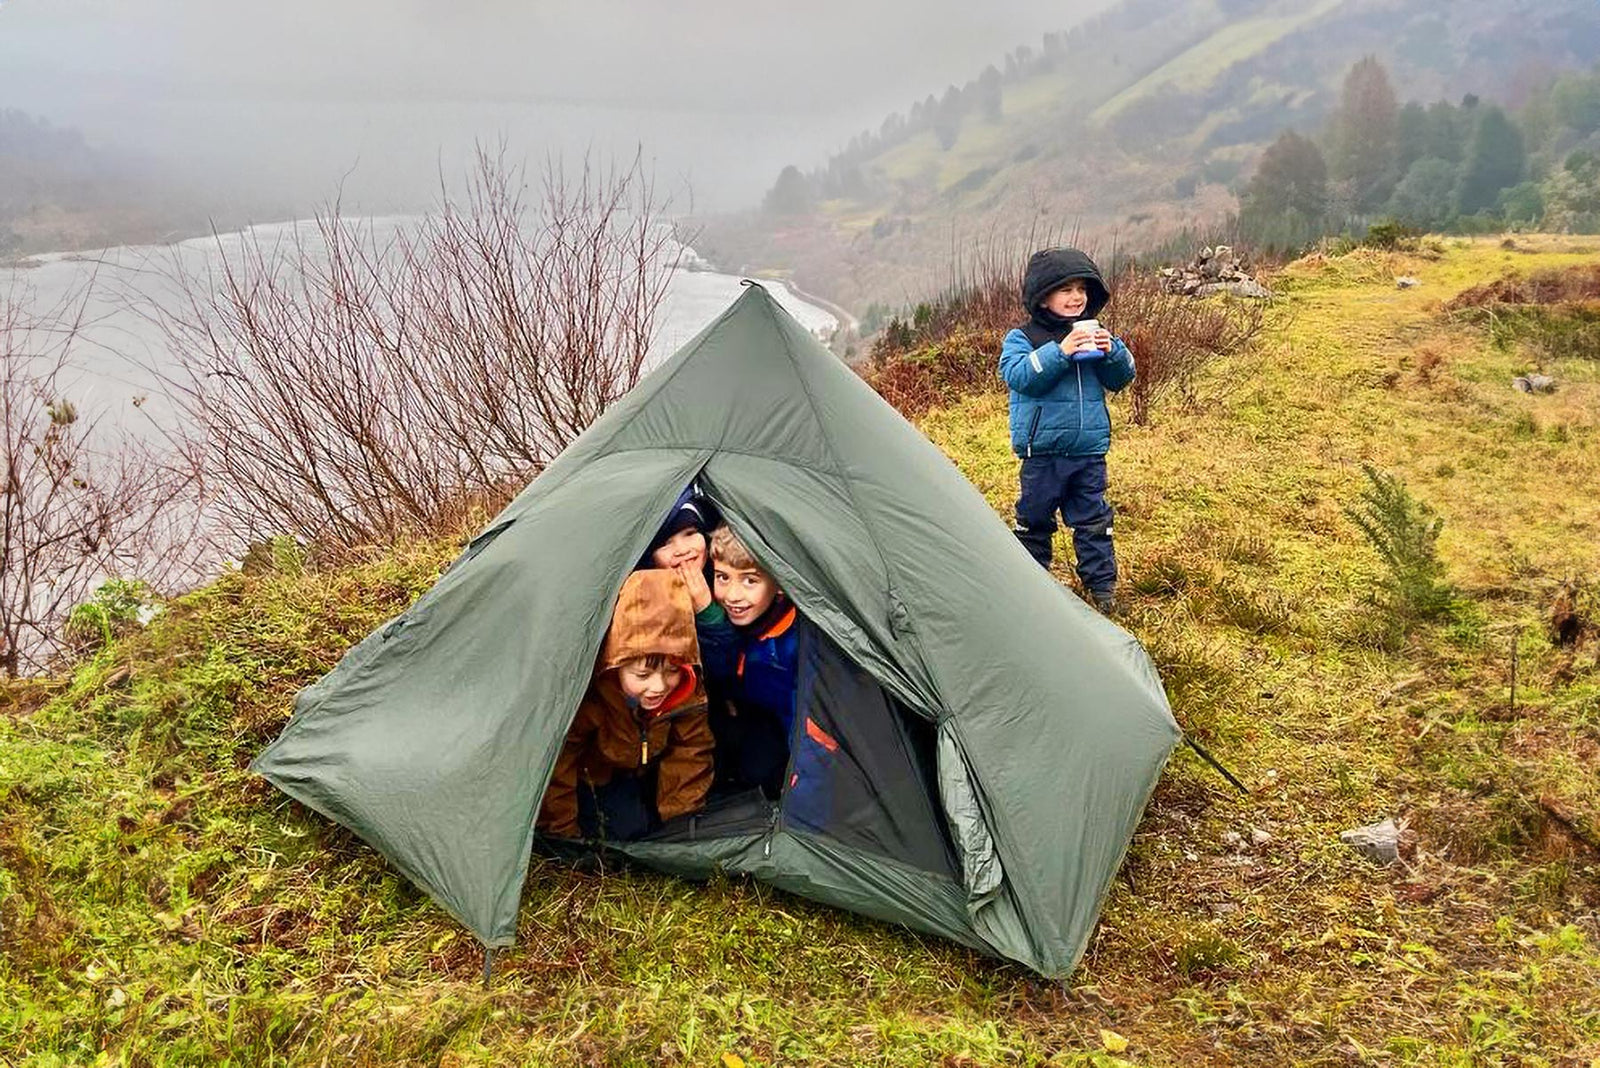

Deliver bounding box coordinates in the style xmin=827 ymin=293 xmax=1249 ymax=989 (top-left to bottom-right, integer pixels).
xmin=1000 ymin=329 xmax=1133 ymax=457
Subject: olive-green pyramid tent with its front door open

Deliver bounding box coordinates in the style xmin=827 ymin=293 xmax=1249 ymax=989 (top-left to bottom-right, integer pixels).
xmin=254 ymin=285 xmax=1179 ymax=975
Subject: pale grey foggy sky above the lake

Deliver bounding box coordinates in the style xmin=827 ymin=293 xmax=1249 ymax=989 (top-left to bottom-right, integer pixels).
xmin=0 ymin=0 xmax=1110 ymax=209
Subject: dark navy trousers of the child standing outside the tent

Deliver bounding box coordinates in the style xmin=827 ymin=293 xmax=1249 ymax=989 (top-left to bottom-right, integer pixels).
xmin=1016 ymin=456 xmax=1117 ymax=593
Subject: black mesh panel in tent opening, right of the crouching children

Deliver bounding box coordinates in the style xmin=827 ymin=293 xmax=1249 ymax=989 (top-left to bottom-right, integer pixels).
xmin=779 ymin=624 xmax=960 ymax=879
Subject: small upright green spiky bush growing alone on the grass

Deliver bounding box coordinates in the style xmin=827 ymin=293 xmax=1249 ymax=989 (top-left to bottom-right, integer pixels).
xmin=1344 ymin=464 xmax=1456 ymax=619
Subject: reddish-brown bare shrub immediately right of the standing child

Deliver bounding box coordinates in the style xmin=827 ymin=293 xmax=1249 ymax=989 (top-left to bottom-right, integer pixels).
xmin=1102 ymin=270 xmax=1262 ymax=425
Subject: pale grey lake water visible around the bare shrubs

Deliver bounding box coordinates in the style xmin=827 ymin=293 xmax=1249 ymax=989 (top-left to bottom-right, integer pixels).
xmin=0 ymin=217 xmax=837 ymax=427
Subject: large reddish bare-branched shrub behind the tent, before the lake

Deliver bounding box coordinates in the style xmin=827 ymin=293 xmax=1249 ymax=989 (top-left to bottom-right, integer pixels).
xmin=158 ymin=150 xmax=678 ymax=550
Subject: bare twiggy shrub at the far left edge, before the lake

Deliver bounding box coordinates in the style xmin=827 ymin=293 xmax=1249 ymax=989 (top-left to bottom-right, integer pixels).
xmin=0 ymin=287 xmax=186 ymax=678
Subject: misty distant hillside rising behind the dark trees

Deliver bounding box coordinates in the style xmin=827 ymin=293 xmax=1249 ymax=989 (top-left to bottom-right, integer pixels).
xmin=696 ymin=0 xmax=1600 ymax=313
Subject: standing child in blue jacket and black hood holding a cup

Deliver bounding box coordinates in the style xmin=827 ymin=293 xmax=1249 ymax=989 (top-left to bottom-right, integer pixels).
xmin=1000 ymin=248 xmax=1133 ymax=612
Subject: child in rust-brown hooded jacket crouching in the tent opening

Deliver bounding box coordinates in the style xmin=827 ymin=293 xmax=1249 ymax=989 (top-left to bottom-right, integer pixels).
xmin=538 ymin=571 xmax=715 ymax=841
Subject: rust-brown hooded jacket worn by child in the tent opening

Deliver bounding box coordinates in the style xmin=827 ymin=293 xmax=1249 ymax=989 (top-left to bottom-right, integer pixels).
xmin=538 ymin=571 xmax=715 ymax=838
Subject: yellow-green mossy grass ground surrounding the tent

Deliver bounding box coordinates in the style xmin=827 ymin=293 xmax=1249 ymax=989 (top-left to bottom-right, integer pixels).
xmin=0 ymin=238 xmax=1600 ymax=1066
